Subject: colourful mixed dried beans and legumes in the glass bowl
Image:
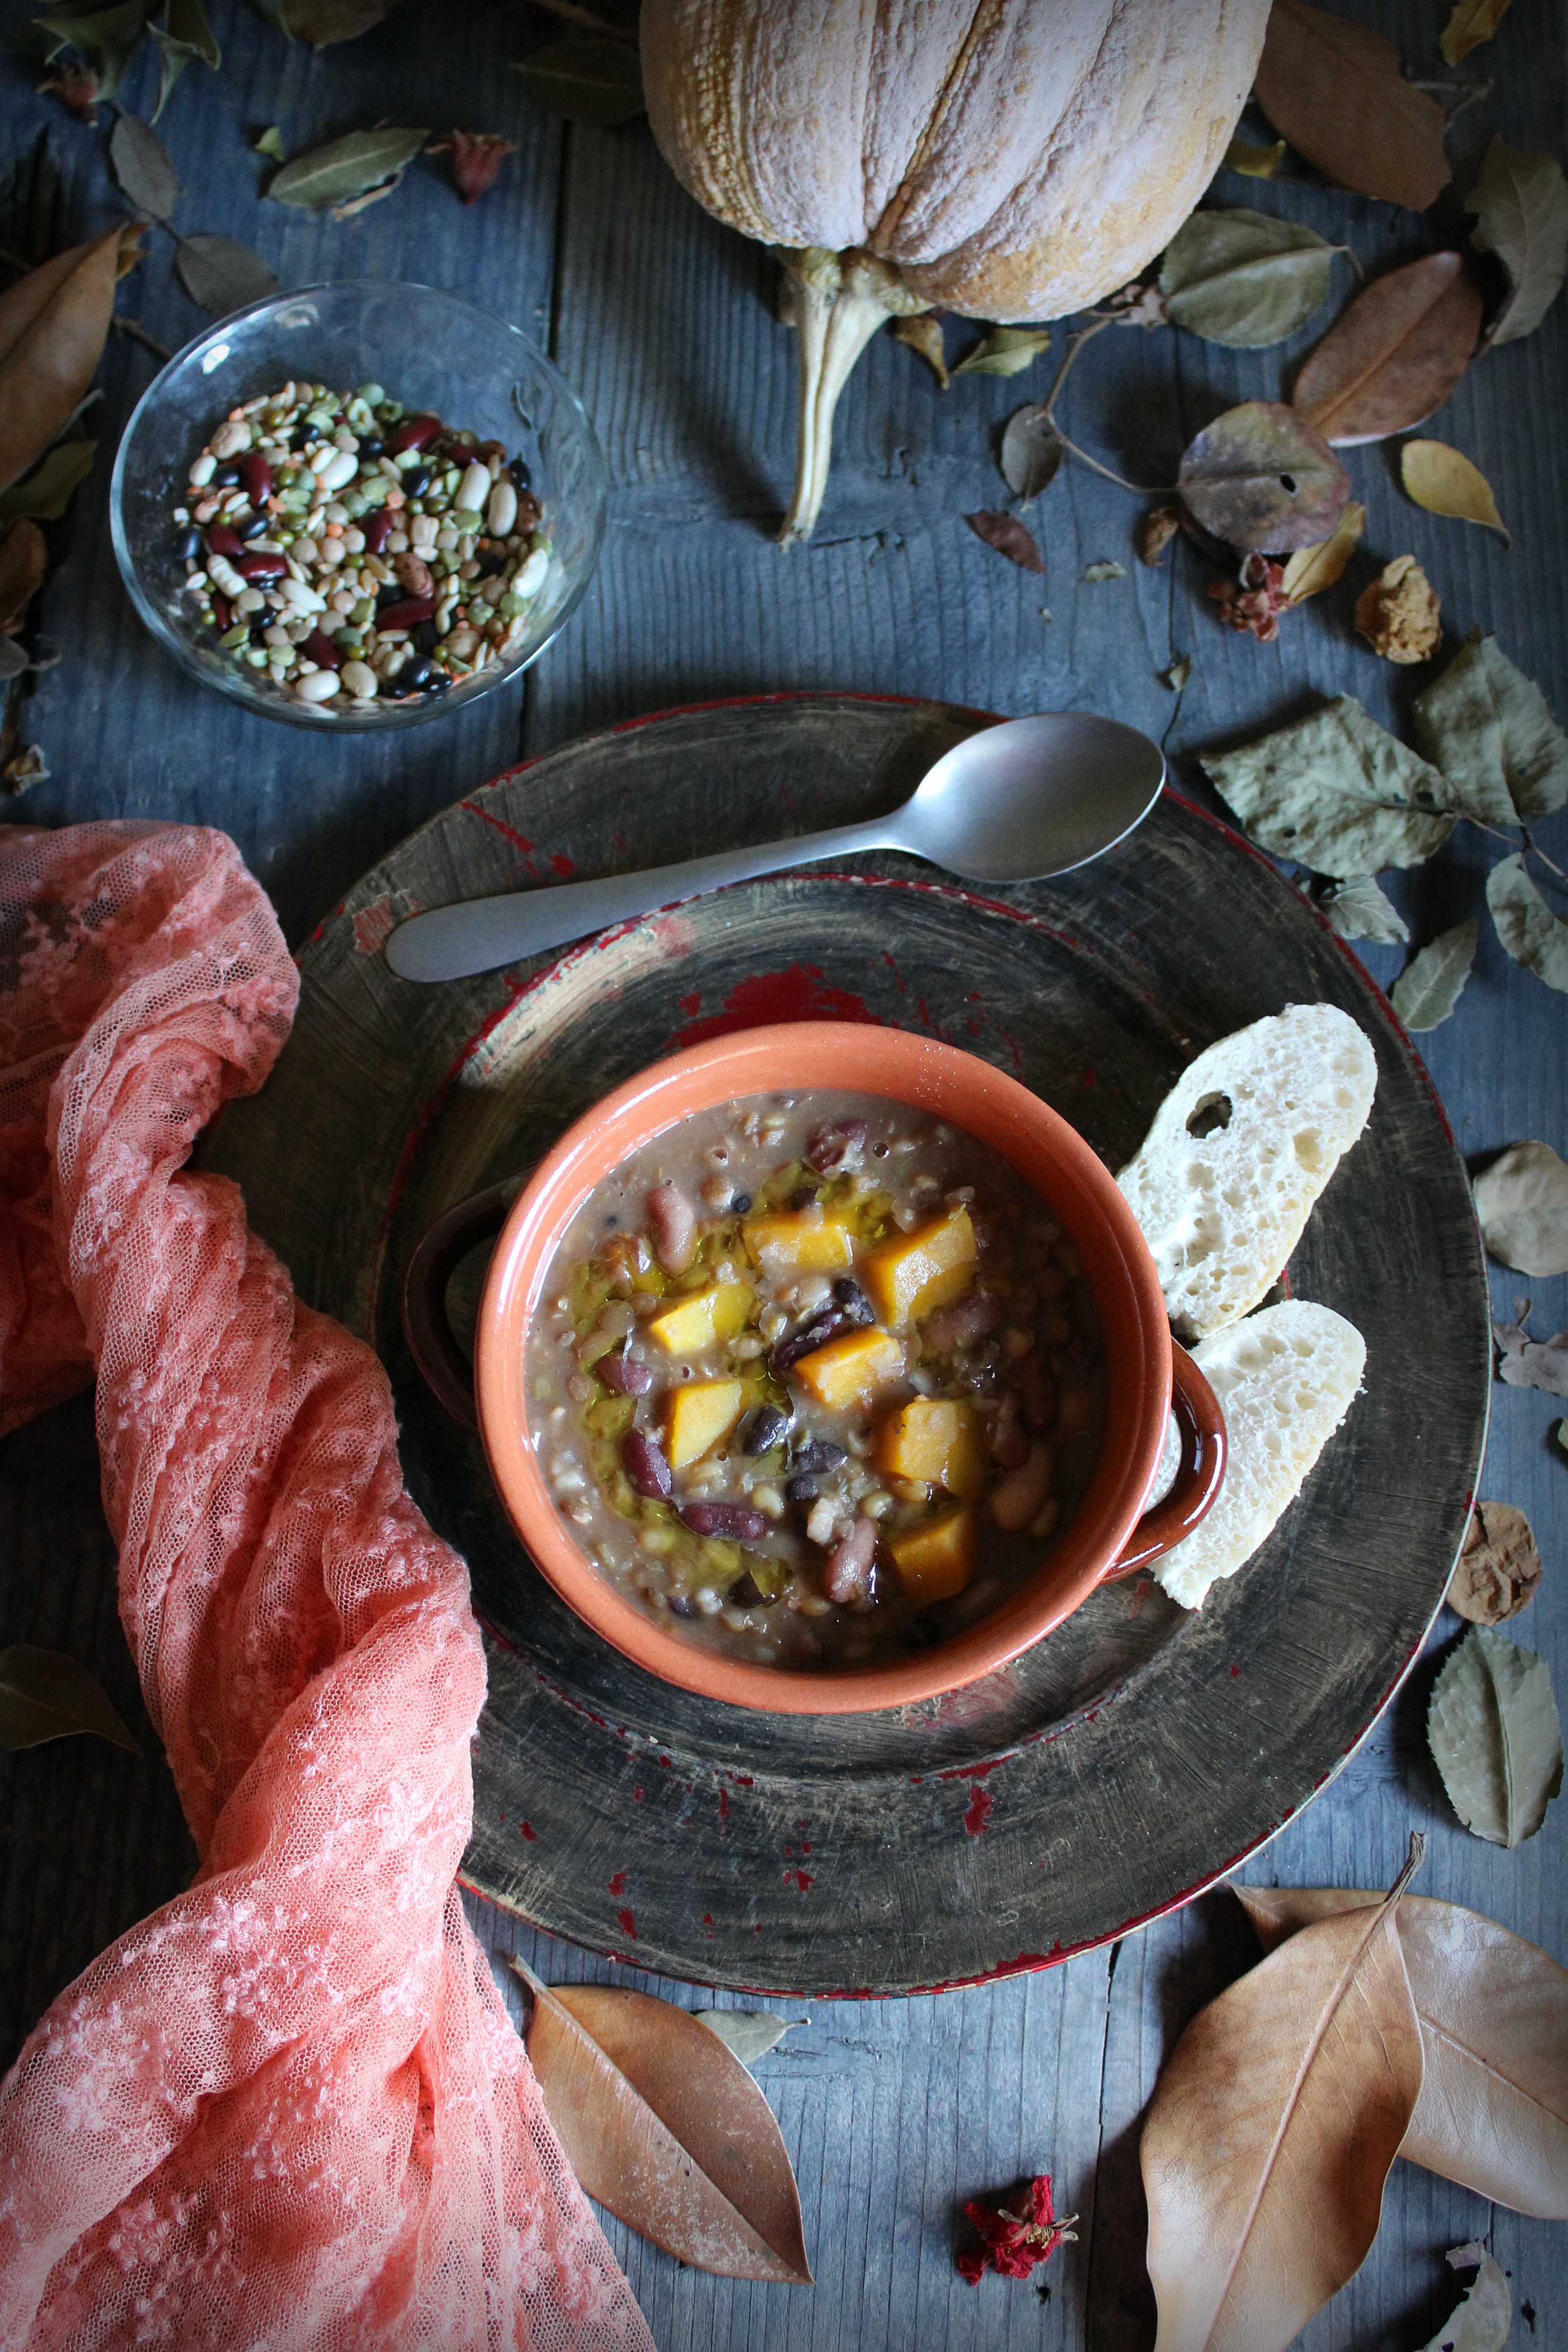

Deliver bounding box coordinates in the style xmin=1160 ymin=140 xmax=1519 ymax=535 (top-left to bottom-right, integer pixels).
xmin=174 ymin=383 xmax=550 ymax=712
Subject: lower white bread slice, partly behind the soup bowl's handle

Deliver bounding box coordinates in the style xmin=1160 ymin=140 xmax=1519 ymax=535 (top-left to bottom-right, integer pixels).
xmin=1154 ymin=1299 xmax=1366 ymax=1609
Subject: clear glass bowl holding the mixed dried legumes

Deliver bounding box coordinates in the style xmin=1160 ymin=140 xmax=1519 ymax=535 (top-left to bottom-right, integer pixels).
xmin=108 ymin=280 xmax=609 ymax=731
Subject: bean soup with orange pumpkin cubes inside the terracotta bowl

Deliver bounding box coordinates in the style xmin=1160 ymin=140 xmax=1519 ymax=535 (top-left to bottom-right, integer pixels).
xmin=529 ymin=1091 xmax=1103 ymax=1668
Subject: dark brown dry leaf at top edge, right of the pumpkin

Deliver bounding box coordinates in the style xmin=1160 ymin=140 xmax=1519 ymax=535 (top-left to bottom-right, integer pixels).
xmin=1253 ymin=0 xmax=1450 ymax=212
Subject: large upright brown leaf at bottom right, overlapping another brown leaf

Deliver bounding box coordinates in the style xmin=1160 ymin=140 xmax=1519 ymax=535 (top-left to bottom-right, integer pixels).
xmin=1143 ymin=1839 xmax=1422 ymax=2352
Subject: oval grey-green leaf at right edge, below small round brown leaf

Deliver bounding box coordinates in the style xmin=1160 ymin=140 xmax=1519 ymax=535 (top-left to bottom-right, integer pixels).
xmin=1427 ymin=1625 xmax=1563 ymax=1846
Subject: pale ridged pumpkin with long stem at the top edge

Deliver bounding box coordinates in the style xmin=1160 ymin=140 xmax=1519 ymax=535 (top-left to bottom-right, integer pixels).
xmin=642 ymin=0 xmax=1269 ymax=543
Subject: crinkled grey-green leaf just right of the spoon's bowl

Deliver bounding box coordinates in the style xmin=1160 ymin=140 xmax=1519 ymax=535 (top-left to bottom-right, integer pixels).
xmin=1199 ymin=694 xmax=1455 ymax=879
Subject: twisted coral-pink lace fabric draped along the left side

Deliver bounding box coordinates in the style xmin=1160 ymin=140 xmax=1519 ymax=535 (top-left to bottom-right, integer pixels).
xmin=0 ymin=823 xmax=651 ymax=2352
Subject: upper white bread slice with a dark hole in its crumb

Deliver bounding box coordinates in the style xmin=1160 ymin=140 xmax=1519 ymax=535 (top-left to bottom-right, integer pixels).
xmin=1117 ymin=1004 xmax=1378 ymax=1339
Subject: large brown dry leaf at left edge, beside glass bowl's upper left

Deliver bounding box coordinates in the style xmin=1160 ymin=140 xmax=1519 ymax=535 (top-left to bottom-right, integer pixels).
xmin=0 ymin=226 xmax=125 ymax=489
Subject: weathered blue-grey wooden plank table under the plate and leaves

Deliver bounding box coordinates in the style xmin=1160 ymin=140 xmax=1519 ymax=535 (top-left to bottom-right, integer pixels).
xmin=0 ymin=0 xmax=1568 ymax=2352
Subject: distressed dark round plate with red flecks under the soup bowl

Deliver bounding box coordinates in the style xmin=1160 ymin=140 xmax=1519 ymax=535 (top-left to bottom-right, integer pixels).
xmin=207 ymin=694 xmax=1490 ymax=1992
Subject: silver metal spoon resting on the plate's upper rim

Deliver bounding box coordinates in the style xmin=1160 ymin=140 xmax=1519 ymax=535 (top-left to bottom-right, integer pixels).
xmin=386 ymin=710 xmax=1166 ymax=981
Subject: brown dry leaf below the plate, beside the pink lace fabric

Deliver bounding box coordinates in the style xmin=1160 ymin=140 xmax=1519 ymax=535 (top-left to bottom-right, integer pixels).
xmin=512 ymin=1959 xmax=811 ymax=2286
